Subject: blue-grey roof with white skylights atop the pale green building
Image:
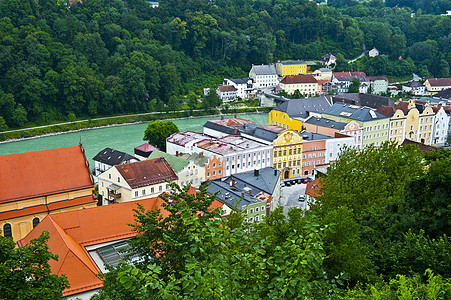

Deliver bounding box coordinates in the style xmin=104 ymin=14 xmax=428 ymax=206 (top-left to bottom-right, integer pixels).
xmin=324 ymin=103 xmax=387 ymax=122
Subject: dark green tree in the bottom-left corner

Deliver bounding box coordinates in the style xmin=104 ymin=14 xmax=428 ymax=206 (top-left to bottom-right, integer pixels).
xmin=0 ymin=232 xmax=69 ymax=300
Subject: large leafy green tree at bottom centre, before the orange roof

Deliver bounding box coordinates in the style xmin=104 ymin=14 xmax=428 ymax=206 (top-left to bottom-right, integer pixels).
xmin=97 ymin=184 xmax=339 ymax=299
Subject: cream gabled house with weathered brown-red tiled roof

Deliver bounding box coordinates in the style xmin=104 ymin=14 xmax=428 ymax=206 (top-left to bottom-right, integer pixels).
xmin=99 ymin=157 xmax=178 ymax=205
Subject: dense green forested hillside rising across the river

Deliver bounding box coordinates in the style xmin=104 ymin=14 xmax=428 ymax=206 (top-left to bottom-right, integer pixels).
xmin=0 ymin=0 xmax=451 ymax=130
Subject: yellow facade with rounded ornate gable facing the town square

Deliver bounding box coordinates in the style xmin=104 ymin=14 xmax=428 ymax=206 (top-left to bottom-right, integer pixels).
xmin=273 ymin=129 xmax=302 ymax=179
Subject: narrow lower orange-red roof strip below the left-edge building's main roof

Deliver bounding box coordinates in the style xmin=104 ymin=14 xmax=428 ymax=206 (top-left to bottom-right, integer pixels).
xmin=0 ymin=196 xmax=96 ymax=221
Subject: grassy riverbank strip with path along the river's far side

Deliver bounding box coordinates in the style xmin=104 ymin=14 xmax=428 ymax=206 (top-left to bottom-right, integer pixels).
xmin=0 ymin=107 xmax=272 ymax=144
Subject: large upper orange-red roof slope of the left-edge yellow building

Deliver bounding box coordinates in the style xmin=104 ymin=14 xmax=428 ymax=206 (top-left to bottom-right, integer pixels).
xmin=0 ymin=146 xmax=94 ymax=203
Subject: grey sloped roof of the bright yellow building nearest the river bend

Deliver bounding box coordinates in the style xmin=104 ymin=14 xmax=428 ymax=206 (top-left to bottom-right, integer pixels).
xmin=274 ymin=96 xmax=330 ymax=119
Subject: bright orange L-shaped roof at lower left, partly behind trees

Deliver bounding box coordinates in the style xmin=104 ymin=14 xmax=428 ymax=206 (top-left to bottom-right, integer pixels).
xmin=18 ymin=187 xmax=222 ymax=296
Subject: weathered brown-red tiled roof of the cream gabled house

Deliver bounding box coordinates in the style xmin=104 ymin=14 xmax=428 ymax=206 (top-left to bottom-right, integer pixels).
xmin=114 ymin=157 xmax=178 ymax=189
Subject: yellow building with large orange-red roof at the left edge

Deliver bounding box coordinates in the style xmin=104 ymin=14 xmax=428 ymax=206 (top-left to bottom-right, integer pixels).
xmin=0 ymin=145 xmax=97 ymax=241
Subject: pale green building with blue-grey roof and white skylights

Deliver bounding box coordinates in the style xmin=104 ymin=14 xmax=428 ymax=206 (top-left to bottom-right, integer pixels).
xmin=322 ymin=103 xmax=389 ymax=148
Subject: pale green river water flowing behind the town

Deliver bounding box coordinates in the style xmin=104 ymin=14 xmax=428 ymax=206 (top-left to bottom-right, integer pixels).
xmin=0 ymin=113 xmax=268 ymax=169
